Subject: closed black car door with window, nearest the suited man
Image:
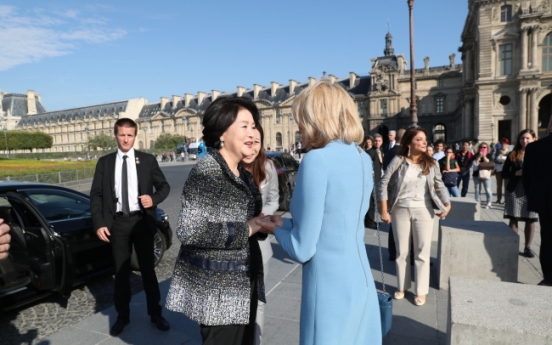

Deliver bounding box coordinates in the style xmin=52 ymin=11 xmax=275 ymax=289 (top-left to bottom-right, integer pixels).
xmin=21 ymin=188 xmax=113 ymax=281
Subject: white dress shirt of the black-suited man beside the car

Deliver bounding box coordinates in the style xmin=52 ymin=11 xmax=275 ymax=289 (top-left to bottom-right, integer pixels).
xmin=115 ymin=149 xmax=140 ymax=212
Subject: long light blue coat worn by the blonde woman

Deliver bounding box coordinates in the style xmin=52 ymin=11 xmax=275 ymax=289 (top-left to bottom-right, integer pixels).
xmin=274 ymin=141 xmax=382 ymax=345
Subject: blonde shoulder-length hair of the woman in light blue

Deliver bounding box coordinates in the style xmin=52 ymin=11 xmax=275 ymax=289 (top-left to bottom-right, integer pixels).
xmin=291 ymin=80 xmax=364 ymax=149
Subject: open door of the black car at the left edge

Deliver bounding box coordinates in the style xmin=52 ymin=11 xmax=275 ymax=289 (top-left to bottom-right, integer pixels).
xmin=6 ymin=192 xmax=74 ymax=297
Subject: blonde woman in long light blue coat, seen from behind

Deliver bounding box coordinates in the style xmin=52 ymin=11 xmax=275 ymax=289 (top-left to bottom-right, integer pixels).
xmin=258 ymin=81 xmax=382 ymax=345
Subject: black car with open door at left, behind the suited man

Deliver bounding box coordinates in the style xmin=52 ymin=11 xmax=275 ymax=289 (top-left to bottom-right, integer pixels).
xmin=0 ymin=182 xmax=172 ymax=309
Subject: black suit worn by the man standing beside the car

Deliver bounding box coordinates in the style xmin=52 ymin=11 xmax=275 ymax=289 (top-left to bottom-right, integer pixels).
xmin=90 ymin=150 xmax=170 ymax=320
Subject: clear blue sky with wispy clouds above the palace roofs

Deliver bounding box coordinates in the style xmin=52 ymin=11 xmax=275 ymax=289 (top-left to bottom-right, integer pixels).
xmin=0 ymin=0 xmax=468 ymax=111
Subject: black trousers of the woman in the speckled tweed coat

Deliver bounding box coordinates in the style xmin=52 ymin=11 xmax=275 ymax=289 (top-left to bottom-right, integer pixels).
xmin=200 ymin=274 xmax=259 ymax=345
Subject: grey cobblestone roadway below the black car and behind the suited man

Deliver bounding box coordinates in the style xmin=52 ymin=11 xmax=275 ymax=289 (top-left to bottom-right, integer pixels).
xmin=0 ymin=165 xmax=192 ymax=345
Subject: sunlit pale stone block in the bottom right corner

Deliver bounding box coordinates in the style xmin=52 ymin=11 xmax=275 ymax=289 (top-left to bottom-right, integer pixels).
xmin=447 ymin=277 xmax=552 ymax=345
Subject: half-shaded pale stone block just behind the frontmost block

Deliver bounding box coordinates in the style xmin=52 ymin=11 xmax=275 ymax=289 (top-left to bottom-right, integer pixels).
xmin=437 ymin=219 xmax=519 ymax=290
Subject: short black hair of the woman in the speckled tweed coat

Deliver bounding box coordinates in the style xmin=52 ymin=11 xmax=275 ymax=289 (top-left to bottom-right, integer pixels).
xmin=202 ymin=97 xmax=259 ymax=149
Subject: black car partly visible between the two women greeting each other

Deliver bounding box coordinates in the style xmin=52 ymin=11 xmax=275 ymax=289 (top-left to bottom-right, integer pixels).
xmin=266 ymin=152 xmax=299 ymax=211
